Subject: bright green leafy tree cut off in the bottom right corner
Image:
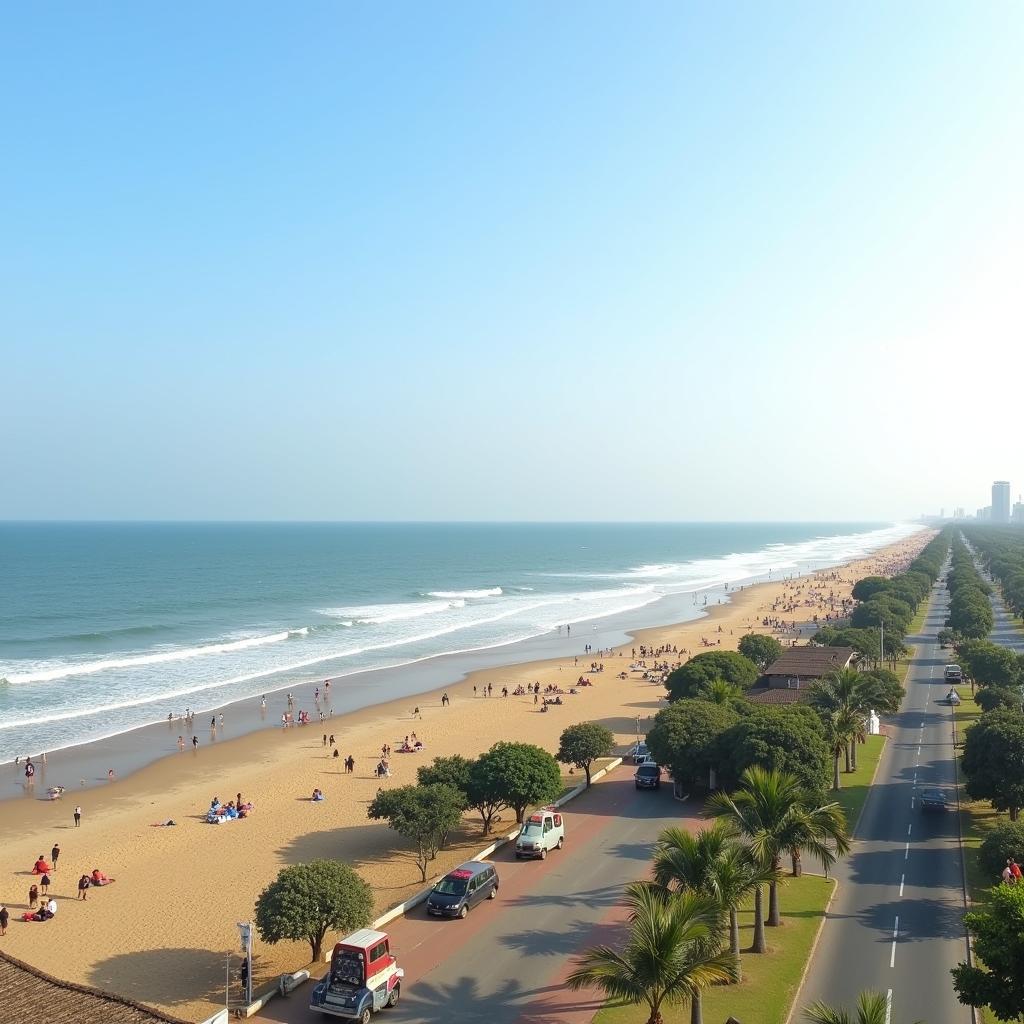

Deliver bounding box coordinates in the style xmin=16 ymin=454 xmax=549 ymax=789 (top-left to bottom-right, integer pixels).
xmin=952 ymin=885 xmax=1024 ymax=1021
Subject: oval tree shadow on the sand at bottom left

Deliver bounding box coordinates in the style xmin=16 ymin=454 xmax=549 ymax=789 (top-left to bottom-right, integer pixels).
xmin=89 ymin=948 xmax=234 ymax=1007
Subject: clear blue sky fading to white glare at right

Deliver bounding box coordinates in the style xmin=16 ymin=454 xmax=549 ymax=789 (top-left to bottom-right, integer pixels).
xmin=0 ymin=3 xmax=1024 ymax=520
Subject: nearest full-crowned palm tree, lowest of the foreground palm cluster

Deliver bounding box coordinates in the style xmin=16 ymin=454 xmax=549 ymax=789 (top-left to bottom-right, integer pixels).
xmin=566 ymin=882 xmax=736 ymax=1024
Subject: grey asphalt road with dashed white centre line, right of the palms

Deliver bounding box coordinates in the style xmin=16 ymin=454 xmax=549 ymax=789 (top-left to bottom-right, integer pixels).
xmin=800 ymin=587 xmax=971 ymax=1024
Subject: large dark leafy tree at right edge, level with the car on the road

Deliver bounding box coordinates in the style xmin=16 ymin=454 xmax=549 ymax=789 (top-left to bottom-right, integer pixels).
xmin=962 ymin=708 xmax=1024 ymax=821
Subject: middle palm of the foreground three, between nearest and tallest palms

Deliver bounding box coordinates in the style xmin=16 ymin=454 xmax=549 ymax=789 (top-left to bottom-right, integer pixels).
xmin=654 ymin=821 xmax=775 ymax=981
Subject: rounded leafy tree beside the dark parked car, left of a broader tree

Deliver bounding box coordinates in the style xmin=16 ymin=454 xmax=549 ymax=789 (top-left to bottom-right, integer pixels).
xmin=647 ymin=700 xmax=739 ymax=788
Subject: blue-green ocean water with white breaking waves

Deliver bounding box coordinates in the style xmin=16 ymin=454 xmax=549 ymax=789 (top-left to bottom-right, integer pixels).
xmin=0 ymin=523 xmax=915 ymax=761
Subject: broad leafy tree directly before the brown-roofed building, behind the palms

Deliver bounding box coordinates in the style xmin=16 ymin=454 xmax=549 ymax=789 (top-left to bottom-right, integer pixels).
xmin=719 ymin=705 xmax=831 ymax=794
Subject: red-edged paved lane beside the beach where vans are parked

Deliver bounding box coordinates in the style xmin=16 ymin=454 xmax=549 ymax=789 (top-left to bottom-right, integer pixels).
xmin=260 ymin=765 xmax=696 ymax=1024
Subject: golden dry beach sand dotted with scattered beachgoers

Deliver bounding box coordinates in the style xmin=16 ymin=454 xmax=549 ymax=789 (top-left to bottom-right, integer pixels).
xmin=0 ymin=531 xmax=933 ymax=1021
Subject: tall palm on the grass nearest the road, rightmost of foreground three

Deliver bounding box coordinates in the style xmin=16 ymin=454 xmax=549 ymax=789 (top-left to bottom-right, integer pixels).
xmin=705 ymin=765 xmax=850 ymax=928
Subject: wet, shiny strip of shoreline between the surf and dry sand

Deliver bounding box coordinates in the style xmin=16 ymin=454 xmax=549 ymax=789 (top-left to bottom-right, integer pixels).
xmin=0 ymin=530 xmax=922 ymax=806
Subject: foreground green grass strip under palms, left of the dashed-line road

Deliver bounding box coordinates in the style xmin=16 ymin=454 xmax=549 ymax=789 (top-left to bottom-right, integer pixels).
xmin=594 ymin=874 xmax=836 ymax=1024
